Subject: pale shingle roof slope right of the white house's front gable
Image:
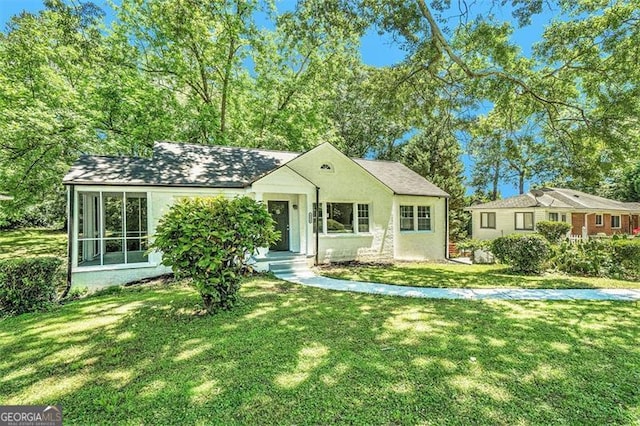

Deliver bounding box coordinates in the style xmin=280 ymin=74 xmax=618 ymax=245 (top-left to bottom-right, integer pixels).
xmin=353 ymin=158 xmax=449 ymax=197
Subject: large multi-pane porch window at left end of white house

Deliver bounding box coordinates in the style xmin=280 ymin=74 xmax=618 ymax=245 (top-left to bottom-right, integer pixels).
xmin=77 ymin=192 xmax=148 ymax=266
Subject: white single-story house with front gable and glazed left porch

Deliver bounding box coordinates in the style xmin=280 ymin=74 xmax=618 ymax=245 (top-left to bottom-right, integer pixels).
xmin=64 ymin=142 xmax=448 ymax=286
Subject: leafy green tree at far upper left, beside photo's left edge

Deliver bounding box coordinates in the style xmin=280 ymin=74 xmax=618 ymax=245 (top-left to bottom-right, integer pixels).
xmin=0 ymin=0 xmax=102 ymax=220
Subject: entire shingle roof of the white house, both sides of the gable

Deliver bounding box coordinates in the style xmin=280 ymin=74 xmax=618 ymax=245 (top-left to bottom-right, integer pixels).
xmin=63 ymin=142 xmax=448 ymax=197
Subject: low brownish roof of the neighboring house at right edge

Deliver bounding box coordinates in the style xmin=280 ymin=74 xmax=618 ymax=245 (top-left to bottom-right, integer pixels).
xmin=466 ymin=188 xmax=639 ymax=211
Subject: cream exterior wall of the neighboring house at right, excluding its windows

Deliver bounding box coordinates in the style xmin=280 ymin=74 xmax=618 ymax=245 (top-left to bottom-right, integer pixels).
xmin=471 ymin=208 xmax=571 ymax=240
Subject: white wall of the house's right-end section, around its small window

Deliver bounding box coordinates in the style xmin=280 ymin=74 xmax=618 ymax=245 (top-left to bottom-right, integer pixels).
xmin=394 ymin=195 xmax=447 ymax=260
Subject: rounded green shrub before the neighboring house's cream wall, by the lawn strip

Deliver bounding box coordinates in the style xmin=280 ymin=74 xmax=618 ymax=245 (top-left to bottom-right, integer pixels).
xmin=491 ymin=234 xmax=551 ymax=274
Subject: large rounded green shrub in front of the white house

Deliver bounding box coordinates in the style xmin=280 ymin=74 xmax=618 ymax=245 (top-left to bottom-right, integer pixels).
xmin=152 ymin=196 xmax=278 ymax=313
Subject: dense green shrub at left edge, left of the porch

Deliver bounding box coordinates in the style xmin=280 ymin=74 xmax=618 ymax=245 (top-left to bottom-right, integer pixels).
xmin=0 ymin=257 xmax=62 ymax=315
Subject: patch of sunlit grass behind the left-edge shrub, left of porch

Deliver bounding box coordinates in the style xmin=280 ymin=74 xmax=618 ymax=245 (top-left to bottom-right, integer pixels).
xmin=0 ymin=229 xmax=67 ymax=259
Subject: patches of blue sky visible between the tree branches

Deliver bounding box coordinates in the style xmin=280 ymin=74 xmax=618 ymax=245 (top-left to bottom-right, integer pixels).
xmin=0 ymin=0 xmax=554 ymax=196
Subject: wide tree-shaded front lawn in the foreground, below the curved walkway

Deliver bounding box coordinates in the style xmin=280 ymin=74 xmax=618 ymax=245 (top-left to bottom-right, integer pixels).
xmin=0 ymin=278 xmax=640 ymax=425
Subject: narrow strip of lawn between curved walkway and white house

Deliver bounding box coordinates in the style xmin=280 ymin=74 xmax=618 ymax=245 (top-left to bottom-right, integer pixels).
xmin=319 ymin=263 xmax=640 ymax=288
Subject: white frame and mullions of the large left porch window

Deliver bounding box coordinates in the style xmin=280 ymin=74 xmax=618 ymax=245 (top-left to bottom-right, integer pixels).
xmin=72 ymin=189 xmax=152 ymax=270
